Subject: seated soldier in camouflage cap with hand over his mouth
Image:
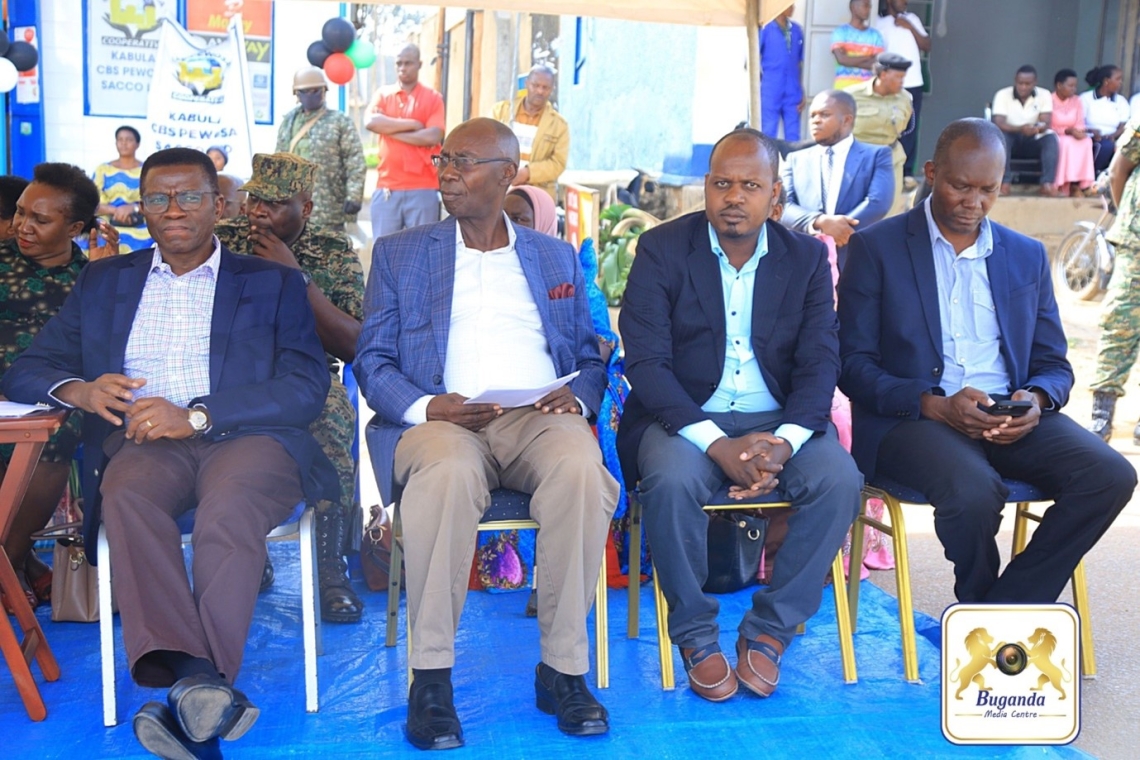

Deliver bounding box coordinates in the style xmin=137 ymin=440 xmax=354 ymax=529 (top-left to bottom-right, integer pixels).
xmin=214 ymin=153 xmax=364 ymax=622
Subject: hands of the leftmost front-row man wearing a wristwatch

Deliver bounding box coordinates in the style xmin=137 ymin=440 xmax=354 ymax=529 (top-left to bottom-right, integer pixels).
xmin=56 ymin=373 xmax=194 ymax=443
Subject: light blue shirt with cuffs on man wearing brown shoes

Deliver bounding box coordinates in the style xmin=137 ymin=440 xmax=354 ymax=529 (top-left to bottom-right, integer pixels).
xmin=677 ymin=224 xmax=812 ymax=456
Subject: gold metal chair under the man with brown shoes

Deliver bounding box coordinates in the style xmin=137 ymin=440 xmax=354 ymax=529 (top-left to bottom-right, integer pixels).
xmin=626 ymin=484 xmax=858 ymax=692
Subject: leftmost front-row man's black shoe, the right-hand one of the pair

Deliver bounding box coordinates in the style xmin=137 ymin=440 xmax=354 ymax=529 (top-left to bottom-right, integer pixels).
xmin=166 ymin=676 xmax=261 ymax=742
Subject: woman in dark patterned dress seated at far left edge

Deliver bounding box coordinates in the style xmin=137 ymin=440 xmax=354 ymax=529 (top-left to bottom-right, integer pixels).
xmin=0 ymin=163 xmax=119 ymax=607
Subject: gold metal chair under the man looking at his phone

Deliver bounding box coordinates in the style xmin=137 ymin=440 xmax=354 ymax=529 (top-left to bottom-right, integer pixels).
xmin=847 ymin=479 xmax=1097 ymax=683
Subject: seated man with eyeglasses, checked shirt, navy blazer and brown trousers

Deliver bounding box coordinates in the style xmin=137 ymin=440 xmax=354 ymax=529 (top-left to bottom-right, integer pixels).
xmin=2 ymin=148 xmax=340 ymax=758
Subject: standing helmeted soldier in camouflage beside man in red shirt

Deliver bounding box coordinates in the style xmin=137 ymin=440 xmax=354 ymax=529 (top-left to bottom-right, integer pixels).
xmin=277 ymin=66 xmax=367 ymax=232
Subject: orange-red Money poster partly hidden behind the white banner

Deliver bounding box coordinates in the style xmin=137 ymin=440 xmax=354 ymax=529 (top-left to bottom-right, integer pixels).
xmin=186 ymin=0 xmax=274 ymax=124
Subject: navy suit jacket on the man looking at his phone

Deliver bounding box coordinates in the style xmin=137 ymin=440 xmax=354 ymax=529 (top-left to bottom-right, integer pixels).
xmin=839 ymin=205 xmax=1073 ymax=480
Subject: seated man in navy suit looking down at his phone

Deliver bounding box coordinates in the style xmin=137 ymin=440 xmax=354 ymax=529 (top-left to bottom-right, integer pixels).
xmin=839 ymin=119 xmax=1137 ymax=603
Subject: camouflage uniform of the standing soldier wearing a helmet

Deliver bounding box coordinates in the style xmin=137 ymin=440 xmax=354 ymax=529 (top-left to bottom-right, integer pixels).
xmin=277 ymin=106 xmax=367 ymax=233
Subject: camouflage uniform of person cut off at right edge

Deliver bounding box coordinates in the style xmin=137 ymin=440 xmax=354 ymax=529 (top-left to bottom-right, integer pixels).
xmin=1092 ymin=119 xmax=1140 ymax=397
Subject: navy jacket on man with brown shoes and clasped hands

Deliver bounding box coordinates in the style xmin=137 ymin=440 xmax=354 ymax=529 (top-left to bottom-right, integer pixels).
xmin=618 ymin=211 xmax=839 ymax=483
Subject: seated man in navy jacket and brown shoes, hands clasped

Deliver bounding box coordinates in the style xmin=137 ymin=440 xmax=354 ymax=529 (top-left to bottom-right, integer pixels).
xmin=618 ymin=129 xmax=862 ymax=702
